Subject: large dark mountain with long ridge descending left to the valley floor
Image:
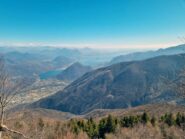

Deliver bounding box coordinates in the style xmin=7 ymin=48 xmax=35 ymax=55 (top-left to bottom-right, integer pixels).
xmin=30 ymin=54 xmax=185 ymax=114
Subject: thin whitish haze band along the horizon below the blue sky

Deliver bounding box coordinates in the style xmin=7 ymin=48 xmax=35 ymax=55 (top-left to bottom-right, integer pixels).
xmin=0 ymin=42 xmax=184 ymax=50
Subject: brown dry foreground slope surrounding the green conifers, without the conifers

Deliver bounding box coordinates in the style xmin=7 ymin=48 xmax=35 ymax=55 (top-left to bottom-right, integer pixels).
xmin=4 ymin=104 xmax=185 ymax=139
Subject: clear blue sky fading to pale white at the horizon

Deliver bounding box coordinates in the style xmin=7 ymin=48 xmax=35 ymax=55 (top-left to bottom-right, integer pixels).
xmin=0 ymin=0 xmax=185 ymax=48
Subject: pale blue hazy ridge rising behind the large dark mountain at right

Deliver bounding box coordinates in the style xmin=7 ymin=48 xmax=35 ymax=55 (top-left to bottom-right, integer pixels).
xmin=109 ymin=44 xmax=185 ymax=65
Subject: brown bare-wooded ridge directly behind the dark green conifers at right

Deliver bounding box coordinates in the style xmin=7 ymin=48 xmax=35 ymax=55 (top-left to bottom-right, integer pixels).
xmin=83 ymin=103 xmax=185 ymax=119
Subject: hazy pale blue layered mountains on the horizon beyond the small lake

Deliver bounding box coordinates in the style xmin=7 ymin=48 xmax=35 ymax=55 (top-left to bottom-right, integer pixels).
xmin=0 ymin=46 xmax=128 ymax=78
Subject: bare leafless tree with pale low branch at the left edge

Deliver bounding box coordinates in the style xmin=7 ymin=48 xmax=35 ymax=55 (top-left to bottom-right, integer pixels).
xmin=0 ymin=57 xmax=27 ymax=139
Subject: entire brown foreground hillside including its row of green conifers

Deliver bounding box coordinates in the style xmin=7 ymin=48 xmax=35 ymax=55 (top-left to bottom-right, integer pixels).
xmin=4 ymin=104 xmax=185 ymax=139
